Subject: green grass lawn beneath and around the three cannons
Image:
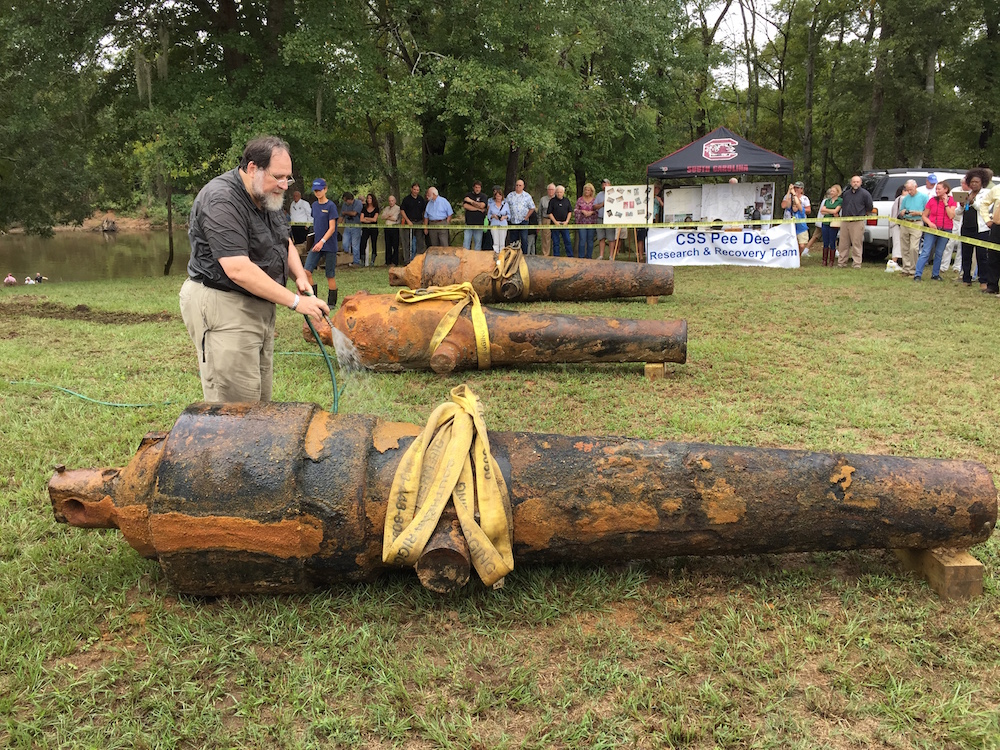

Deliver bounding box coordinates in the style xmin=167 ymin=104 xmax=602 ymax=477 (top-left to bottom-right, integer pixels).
xmin=0 ymin=258 xmax=1000 ymax=750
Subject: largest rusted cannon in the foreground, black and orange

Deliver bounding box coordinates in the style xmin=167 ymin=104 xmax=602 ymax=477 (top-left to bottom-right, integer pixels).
xmin=49 ymin=403 xmax=997 ymax=594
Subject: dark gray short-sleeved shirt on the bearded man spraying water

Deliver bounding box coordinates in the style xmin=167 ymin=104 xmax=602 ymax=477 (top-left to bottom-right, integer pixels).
xmin=188 ymin=169 xmax=288 ymax=296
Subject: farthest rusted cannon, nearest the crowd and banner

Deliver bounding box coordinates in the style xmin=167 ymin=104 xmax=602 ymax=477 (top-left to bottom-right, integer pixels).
xmin=389 ymin=247 xmax=674 ymax=302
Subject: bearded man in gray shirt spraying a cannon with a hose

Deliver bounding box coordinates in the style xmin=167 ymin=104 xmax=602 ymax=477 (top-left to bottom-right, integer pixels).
xmin=180 ymin=136 xmax=330 ymax=403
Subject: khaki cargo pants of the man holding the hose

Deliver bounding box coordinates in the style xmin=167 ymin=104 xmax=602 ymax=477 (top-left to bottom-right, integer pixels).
xmin=180 ymin=279 xmax=275 ymax=403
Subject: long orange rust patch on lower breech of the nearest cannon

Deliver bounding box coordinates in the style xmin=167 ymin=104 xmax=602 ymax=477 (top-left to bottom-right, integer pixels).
xmin=149 ymin=513 xmax=323 ymax=559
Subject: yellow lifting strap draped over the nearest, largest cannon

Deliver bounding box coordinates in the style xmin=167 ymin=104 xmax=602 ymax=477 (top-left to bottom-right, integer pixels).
xmin=382 ymin=385 xmax=514 ymax=587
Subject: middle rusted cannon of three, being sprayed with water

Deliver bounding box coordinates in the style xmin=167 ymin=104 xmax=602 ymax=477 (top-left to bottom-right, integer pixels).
xmin=302 ymin=292 xmax=687 ymax=374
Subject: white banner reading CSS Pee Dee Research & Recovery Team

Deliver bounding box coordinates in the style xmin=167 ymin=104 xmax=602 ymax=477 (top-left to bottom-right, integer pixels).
xmin=646 ymin=224 xmax=799 ymax=268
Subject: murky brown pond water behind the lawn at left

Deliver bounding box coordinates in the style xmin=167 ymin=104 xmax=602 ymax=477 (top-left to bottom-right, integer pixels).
xmin=0 ymin=229 xmax=191 ymax=284
